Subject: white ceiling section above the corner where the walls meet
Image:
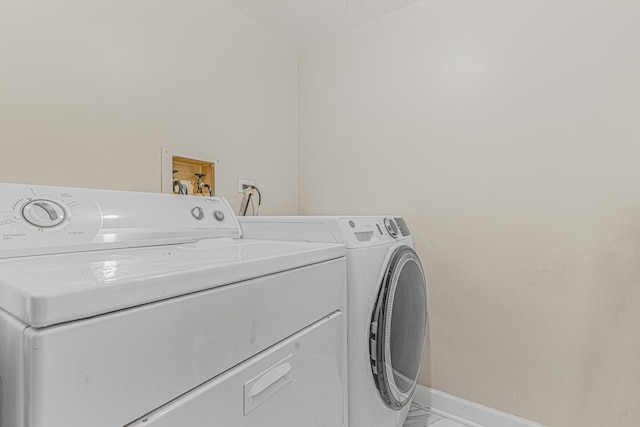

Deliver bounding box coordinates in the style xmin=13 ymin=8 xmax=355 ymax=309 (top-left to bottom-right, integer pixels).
xmin=227 ymin=0 xmax=420 ymax=50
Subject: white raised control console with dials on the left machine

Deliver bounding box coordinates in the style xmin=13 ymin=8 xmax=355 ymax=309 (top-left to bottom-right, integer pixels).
xmin=0 ymin=184 xmax=241 ymax=258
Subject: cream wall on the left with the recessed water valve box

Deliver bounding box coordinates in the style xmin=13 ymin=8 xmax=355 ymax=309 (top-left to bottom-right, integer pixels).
xmin=0 ymin=0 xmax=296 ymax=214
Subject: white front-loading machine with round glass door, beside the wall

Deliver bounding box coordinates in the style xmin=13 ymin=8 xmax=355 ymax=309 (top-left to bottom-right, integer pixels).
xmin=239 ymin=217 xmax=427 ymax=427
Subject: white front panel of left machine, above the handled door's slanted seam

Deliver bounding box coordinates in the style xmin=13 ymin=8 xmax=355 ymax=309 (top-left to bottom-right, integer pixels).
xmin=23 ymin=258 xmax=345 ymax=427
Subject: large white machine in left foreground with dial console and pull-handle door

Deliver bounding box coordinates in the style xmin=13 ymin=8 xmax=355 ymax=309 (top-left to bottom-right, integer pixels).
xmin=0 ymin=184 xmax=347 ymax=427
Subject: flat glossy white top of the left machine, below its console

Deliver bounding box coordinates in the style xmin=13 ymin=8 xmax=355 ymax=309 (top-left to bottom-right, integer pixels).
xmin=0 ymin=238 xmax=345 ymax=327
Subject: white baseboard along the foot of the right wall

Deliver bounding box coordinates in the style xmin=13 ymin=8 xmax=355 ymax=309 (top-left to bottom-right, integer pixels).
xmin=413 ymin=385 xmax=543 ymax=427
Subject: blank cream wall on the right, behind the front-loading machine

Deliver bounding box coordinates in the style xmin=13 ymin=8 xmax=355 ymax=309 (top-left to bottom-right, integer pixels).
xmin=298 ymin=0 xmax=640 ymax=427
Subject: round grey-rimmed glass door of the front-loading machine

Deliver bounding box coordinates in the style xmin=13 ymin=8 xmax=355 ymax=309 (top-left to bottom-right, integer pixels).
xmin=370 ymin=246 xmax=427 ymax=410
